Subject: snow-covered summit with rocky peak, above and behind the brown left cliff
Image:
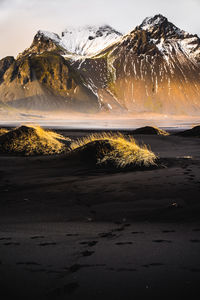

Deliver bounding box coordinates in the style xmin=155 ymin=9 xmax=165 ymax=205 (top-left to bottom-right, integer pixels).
xmin=19 ymin=25 xmax=122 ymax=56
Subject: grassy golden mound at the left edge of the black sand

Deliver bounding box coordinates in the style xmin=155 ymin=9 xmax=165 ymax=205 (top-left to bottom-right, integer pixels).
xmin=0 ymin=126 xmax=69 ymax=155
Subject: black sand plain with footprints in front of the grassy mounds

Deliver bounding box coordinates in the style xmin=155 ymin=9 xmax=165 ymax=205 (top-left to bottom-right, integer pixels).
xmin=0 ymin=132 xmax=200 ymax=300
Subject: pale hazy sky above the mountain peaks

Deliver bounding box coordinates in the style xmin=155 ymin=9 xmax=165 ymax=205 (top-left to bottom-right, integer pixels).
xmin=0 ymin=0 xmax=200 ymax=58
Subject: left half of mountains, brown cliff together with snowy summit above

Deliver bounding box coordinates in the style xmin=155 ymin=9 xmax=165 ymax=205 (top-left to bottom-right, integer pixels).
xmin=0 ymin=26 xmax=121 ymax=113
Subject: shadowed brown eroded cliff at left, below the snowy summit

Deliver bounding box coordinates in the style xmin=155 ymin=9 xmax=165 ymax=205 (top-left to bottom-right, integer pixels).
xmin=0 ymin=51 xmax=99 ymax=112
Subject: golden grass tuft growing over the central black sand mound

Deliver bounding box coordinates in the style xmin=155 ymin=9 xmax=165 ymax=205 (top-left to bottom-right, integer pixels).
xmin=70 ymin=132 xmax=157 ymax=168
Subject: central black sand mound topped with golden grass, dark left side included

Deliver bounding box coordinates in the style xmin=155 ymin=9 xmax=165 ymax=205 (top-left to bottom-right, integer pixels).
xmin=69 ymin=133 xmax=157 ymax=168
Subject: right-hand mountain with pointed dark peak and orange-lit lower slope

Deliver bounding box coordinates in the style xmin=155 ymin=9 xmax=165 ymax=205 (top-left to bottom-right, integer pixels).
xmin=73 ymin=15 xmax=200 ymax=114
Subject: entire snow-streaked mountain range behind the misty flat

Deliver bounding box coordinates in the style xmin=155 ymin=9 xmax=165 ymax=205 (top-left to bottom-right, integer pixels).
xmin=0 ymin=15 xmax=200 ymax=115
